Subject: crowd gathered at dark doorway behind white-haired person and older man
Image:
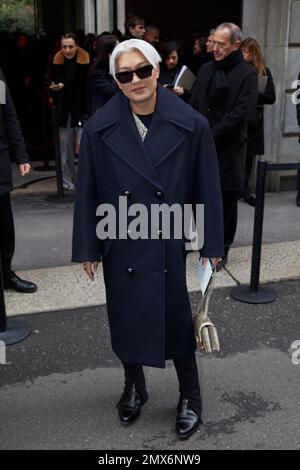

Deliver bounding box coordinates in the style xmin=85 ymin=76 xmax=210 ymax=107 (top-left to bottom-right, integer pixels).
xmin=0 ymin=15 xmax=276 ymax=200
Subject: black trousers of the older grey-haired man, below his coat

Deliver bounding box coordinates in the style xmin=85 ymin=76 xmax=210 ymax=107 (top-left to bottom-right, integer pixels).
xmin=222 ymin=191 xmax=239 ymax=256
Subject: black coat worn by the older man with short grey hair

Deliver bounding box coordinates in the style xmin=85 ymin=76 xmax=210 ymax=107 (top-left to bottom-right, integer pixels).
xmin=191 ymin=61 xmax=258 ymax=191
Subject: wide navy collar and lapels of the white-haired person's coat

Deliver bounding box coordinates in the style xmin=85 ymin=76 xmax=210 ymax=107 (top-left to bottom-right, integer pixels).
xmin=94 ymin=85 xmax=194 ymax=190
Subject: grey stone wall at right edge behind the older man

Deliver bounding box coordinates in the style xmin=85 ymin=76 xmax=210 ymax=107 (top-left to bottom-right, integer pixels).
xmin=243 ymin=0 xmax=300 ymax=191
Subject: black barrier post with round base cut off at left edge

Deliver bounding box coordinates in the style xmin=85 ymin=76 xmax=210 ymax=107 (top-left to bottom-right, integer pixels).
xmin=0 ymin=253 xmax=31 ymax=346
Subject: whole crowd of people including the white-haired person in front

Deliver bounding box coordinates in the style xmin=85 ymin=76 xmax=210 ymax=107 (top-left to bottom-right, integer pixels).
xmin=0 ymin=16 xmax=288 ymax=439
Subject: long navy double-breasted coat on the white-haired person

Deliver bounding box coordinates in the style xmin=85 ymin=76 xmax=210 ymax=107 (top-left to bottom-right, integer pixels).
xmin=72 ymin=85 xmax=223 ymax=368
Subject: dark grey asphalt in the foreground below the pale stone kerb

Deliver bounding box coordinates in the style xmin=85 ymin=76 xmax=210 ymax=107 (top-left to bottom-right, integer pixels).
xmin=0 ymin=281 xmax=300 ymax=451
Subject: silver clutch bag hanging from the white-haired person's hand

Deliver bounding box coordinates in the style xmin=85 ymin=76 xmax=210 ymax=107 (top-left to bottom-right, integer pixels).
xmin=194 ymin=276 xmax=220 ymax=353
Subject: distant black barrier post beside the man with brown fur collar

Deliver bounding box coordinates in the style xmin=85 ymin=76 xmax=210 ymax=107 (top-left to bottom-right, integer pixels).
xmin=46 ymin=106 xmax=74 ymax=203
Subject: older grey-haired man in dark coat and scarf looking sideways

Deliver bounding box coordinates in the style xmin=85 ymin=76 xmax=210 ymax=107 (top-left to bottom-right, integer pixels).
xmin=191 ymin=23 xmax=258 ymax=268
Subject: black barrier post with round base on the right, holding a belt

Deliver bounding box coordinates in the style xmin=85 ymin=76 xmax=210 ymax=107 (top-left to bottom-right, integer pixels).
xmin=231 ymin=161 xmax=277 ymax=304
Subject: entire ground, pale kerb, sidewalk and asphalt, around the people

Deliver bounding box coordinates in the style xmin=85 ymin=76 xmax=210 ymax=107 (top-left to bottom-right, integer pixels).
xmin=0 ymin=166 xmax=300 ymax=451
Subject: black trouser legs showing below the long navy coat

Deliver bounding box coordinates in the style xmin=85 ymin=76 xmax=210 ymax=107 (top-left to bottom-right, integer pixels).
xmin=123 ymin=354 xmax=202 ymax=417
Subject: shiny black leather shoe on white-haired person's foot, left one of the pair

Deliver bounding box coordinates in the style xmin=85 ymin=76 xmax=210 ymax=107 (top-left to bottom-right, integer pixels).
xmin=117 ymin=387 xmax=148 ymax=426
